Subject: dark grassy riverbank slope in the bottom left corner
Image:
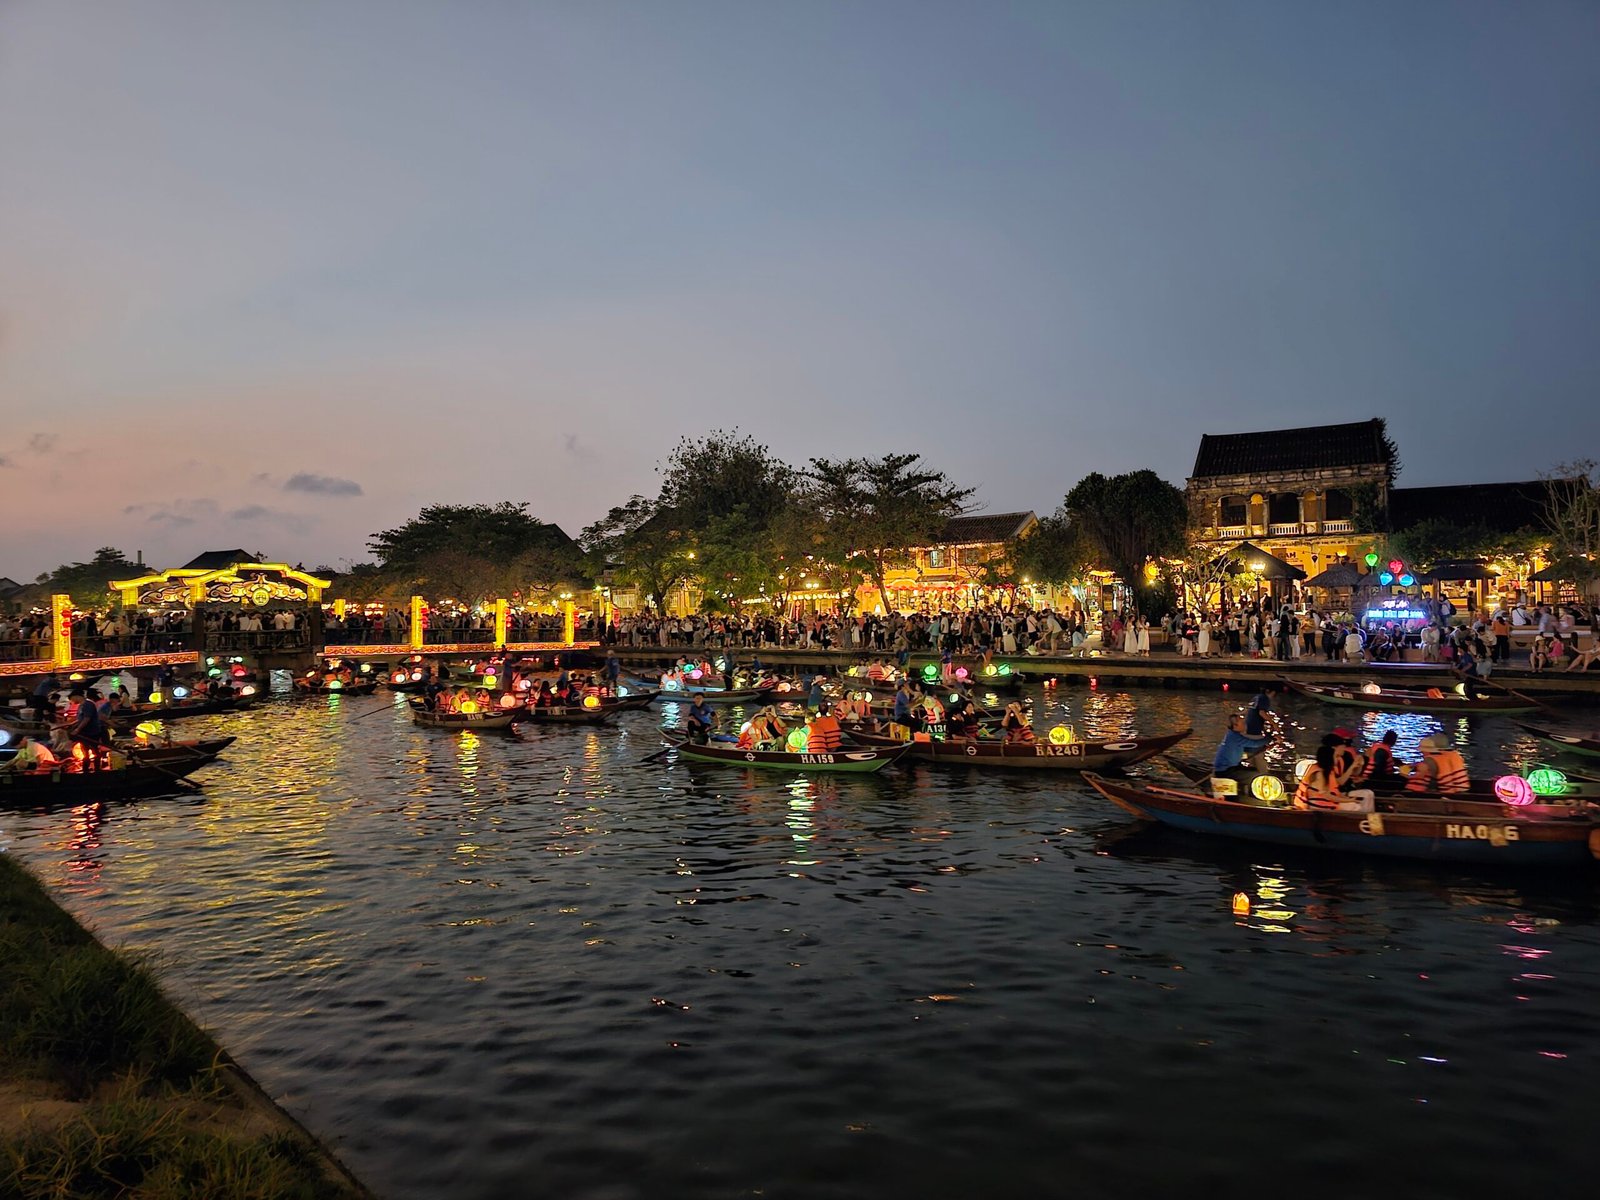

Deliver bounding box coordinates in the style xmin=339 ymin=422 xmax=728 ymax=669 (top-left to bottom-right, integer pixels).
xmin=0 ymin=853 xmax=370 ymax=1200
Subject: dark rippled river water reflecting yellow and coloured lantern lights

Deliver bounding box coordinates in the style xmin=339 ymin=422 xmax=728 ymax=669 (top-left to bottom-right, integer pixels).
xmin=0 ymin=690 xmax=1600 ymax=1200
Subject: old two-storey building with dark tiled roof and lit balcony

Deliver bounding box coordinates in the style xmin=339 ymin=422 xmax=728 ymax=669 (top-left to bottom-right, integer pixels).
xmin=1186 ymin=418 xmax=1395 ymax=574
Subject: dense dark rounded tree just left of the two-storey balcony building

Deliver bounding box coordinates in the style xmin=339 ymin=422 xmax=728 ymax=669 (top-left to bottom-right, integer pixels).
xmin=1061 ymin=470 xmax=1189 ymax=616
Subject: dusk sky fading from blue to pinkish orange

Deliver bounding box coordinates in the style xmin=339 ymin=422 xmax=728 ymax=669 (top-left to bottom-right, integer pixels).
xmin=0 ymin=0 xmax=1600 ymax=581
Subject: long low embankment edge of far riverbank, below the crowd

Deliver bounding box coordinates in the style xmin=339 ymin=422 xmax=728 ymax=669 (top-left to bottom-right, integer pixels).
xmin=594 ymin=646 xmax=1600 ymax=704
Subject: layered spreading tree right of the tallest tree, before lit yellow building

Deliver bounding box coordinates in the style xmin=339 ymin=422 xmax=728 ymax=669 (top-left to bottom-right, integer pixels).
xmin=806 ymin=454 xmax=974 ymax=602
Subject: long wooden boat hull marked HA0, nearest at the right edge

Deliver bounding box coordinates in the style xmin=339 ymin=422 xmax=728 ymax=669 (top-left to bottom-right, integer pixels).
xmin=1083 ymin=771 xmax=1600 ymax=866
